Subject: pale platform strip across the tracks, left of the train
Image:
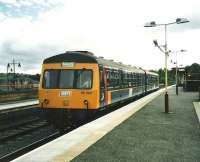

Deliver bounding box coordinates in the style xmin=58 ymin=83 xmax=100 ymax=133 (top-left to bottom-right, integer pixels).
xmin=0 ymin=100 xmax=39 ymax=111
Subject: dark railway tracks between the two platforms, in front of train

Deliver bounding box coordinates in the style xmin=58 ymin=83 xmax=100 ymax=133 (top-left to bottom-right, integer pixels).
xmin=0 ymin=103 xmax=74 ymax=162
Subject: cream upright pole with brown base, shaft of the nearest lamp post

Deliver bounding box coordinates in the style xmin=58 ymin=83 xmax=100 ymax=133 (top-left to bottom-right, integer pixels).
xmin=165 ymin=24 xmax=169 ymax=113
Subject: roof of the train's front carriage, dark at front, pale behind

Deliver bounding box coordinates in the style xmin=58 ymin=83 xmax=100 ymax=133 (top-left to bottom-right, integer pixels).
xmin=43 ymin=51 xmax=145 ymax=73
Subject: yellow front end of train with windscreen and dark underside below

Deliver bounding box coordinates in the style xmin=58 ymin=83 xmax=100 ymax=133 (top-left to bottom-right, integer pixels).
xmin=39 ymin=63 xmax=100 ymax=126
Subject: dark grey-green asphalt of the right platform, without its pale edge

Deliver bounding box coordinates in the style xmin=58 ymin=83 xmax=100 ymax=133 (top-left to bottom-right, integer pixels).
xmin=72 ymin=88 xmax=200 ymax=162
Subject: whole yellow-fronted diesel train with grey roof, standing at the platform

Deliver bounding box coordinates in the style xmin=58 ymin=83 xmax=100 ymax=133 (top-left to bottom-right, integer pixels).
xmin=39 ymin=51 xmax=159 ymax=127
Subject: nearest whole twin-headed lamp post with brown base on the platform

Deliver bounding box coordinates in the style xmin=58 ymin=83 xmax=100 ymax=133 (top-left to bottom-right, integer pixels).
xmin=144 ymin=18 xmax=189 ymax=113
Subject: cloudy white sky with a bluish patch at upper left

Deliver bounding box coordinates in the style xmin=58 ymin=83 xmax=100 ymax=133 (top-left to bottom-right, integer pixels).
xmin=0 ymin=0 xmax=200 ymax=74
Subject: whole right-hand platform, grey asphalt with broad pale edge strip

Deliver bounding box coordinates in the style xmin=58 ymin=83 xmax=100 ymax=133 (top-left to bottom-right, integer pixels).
xmin=13 ymin=87 xmax=200 ymax=162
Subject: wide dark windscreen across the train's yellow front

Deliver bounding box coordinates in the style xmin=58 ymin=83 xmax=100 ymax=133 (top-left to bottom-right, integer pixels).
xmin=43 ymin=69 xmax=92 ymax=89
